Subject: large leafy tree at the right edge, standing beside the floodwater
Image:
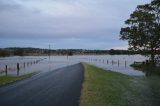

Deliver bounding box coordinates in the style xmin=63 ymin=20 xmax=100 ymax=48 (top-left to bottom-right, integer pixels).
xmin=120 ymin=0 xmax=160 ymax=64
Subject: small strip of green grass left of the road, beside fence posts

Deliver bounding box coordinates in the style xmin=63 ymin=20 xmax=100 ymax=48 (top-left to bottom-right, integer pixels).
xmin=0 ymin=73 xmax=36 ymax=85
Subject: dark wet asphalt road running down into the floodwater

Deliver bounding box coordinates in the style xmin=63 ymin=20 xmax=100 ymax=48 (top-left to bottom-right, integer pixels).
xmin=0 ymin=63 xmax=83 ymax=106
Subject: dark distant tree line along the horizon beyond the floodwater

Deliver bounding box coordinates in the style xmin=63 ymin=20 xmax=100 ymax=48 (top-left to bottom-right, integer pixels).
xmin=0 ymin=47 xmax=153 ymax=57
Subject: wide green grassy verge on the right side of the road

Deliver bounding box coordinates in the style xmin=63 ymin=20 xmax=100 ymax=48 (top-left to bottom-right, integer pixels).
xmin=80 ymin=64 xmax=160 ymax=106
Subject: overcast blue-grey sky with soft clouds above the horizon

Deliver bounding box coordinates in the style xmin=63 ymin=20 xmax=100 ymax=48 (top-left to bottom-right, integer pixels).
xmin=0 ymin=0 xmax=150 ymax=49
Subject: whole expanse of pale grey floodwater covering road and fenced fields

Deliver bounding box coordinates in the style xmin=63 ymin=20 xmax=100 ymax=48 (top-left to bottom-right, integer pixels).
xmin=0 ymin=55 xmax=147 ymax=76
